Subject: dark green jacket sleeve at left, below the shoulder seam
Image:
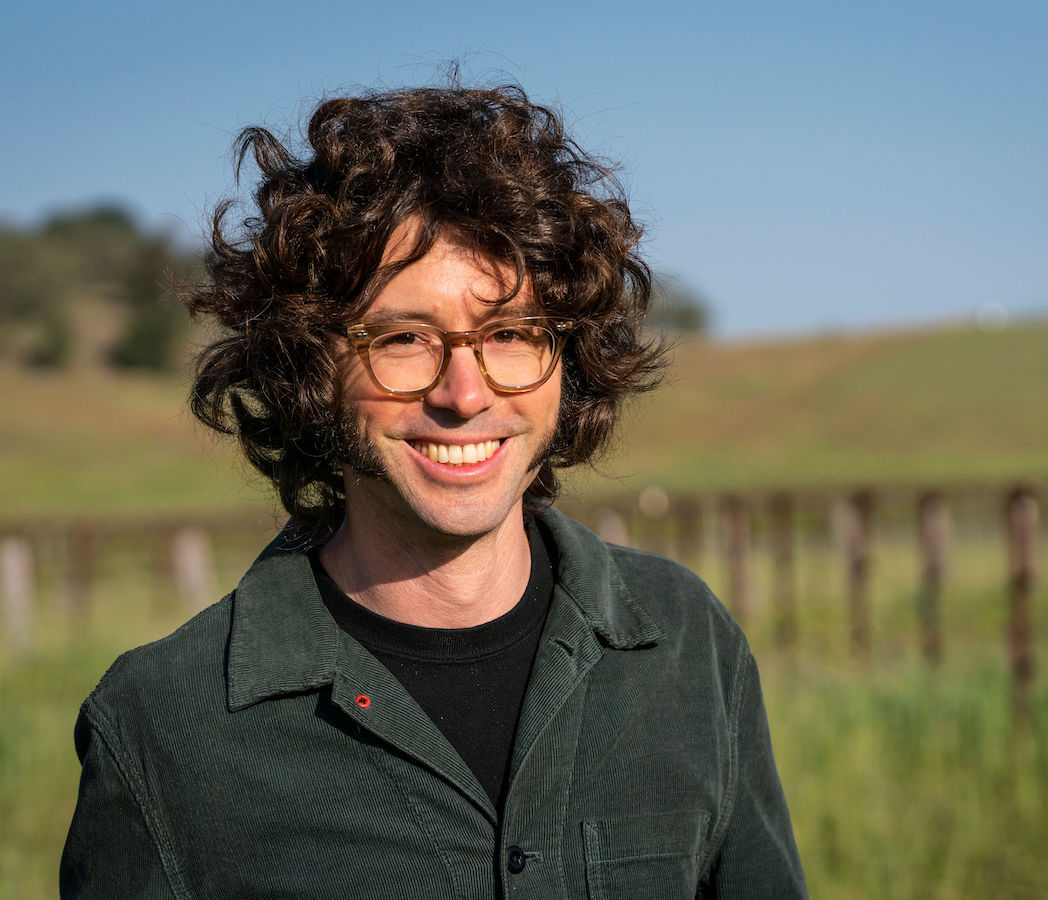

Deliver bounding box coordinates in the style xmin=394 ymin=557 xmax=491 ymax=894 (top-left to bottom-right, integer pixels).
xmin=59 ymin=704 xmax=187 ymax=900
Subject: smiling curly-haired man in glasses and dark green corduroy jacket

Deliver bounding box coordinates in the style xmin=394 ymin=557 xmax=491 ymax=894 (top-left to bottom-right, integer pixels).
xmin=62 ymin=81 xmax=805 ymax=900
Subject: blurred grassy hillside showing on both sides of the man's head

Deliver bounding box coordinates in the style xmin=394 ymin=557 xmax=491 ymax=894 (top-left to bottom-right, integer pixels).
xmin=0 ymin=322 xmax=1048 ymax=515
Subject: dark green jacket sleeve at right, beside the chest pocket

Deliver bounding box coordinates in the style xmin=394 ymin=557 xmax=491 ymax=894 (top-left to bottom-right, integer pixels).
xmin=700 ymin=649 xmax=808 ymax=900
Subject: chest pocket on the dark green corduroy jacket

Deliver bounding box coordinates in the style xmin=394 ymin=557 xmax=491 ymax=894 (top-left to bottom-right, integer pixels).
xmin=583 ymin=810 xmax=709 ymax=900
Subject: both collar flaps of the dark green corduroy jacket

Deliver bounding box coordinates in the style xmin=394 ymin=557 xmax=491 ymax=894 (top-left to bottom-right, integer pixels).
xmin=227 ymin=507 xmax=664 ymax=711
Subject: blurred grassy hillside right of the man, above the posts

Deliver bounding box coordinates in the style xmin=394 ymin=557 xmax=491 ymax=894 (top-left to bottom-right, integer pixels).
xmin=593 ymin=322 xmax=1048 ymax=500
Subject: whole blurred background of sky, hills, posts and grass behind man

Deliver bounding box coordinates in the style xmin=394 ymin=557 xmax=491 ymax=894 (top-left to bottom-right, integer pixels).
xmin=0 ymin=0 xmax=1048 ymax=898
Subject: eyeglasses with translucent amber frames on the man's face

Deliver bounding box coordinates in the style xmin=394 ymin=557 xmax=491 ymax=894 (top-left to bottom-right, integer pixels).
xmin=346 ymin=315 xmax=575 ymax=399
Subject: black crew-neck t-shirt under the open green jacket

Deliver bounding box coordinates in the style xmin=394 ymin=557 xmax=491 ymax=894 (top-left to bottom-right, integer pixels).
xmin=310 ymin=518 xmax=553 ymax=808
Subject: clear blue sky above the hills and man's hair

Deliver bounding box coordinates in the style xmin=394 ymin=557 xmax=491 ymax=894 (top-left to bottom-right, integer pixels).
xmin=0 ymin=0 xmax=1048 ymax=337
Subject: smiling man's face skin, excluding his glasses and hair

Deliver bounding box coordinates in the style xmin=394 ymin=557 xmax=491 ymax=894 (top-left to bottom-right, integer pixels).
xmin=345 ymin=227 xmax=561 ymax=536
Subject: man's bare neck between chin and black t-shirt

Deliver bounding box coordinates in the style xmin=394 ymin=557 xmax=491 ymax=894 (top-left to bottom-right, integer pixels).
xmin=320 ymin=504 xmax=531 ymax=628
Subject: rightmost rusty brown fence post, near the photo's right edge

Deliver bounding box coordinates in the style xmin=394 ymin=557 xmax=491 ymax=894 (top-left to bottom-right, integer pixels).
xmin=1007 ymin=487 xmax=1039 ymax=728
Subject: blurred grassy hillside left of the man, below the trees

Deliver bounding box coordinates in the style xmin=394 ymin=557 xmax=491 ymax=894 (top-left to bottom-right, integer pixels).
xmin=0 ymin=368 xmax=268 ymax=517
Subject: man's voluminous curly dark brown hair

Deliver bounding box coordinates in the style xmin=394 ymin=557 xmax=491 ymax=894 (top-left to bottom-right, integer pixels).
xmin=185 ymin=79 xmax=662 ymax=543
